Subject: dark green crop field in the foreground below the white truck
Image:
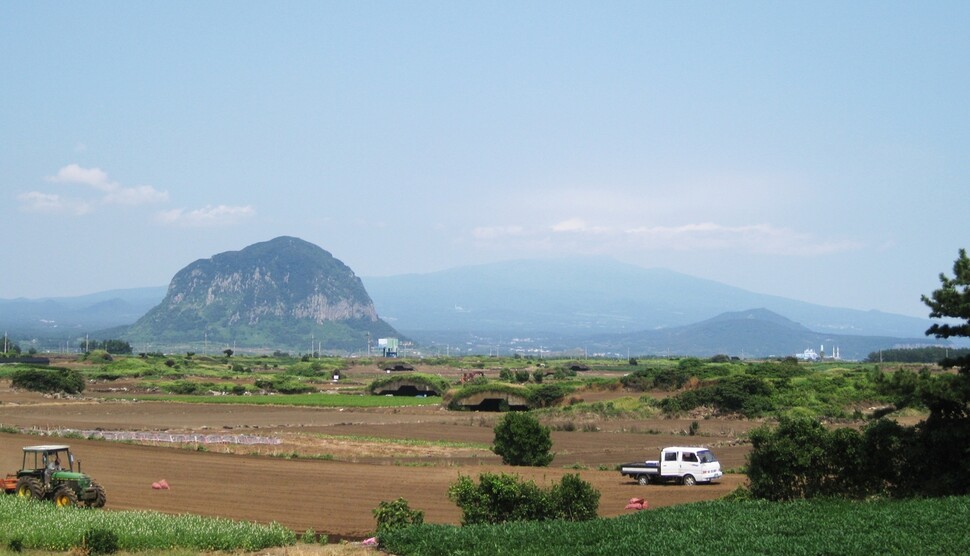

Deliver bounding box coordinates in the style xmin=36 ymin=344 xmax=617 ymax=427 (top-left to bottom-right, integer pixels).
xmin=380 ymin=497 xmax=970 ymax=556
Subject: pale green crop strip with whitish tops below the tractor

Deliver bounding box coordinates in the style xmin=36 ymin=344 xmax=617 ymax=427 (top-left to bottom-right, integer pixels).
xmin=0 ymin=496 xmax=296 ymax=551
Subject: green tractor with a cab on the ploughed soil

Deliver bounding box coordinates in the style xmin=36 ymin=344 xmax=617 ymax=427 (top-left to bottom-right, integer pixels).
xmin=15 ymin=445 xmax=105 ymax=508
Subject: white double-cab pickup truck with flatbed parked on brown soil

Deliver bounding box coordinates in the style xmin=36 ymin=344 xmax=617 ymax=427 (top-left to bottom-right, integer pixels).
xmin=620 ymin=446 xmax=723 ymax=486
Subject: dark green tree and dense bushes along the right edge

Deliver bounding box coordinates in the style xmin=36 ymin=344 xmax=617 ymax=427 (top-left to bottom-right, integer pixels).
xmin=748 ymin=249 xmax=970 ymax=500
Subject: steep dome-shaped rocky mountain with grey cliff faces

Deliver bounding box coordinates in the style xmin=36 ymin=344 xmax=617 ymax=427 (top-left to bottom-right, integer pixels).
xmin=124 ymin=237 xmax=398 ymax=351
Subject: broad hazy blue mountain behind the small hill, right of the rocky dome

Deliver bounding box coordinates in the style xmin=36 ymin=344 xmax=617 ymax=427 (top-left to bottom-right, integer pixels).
xmin=364 ymin=258 xmax=930 ymax=337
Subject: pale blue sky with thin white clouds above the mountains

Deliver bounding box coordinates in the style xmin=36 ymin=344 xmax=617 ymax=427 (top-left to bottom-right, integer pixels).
xmin=0 ymin=1 xmax=970 ymax=316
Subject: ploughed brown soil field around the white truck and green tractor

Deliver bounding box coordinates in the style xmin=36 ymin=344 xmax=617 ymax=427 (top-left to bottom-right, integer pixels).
xmin=0 ymin=381 xmax=757 ymax=540
